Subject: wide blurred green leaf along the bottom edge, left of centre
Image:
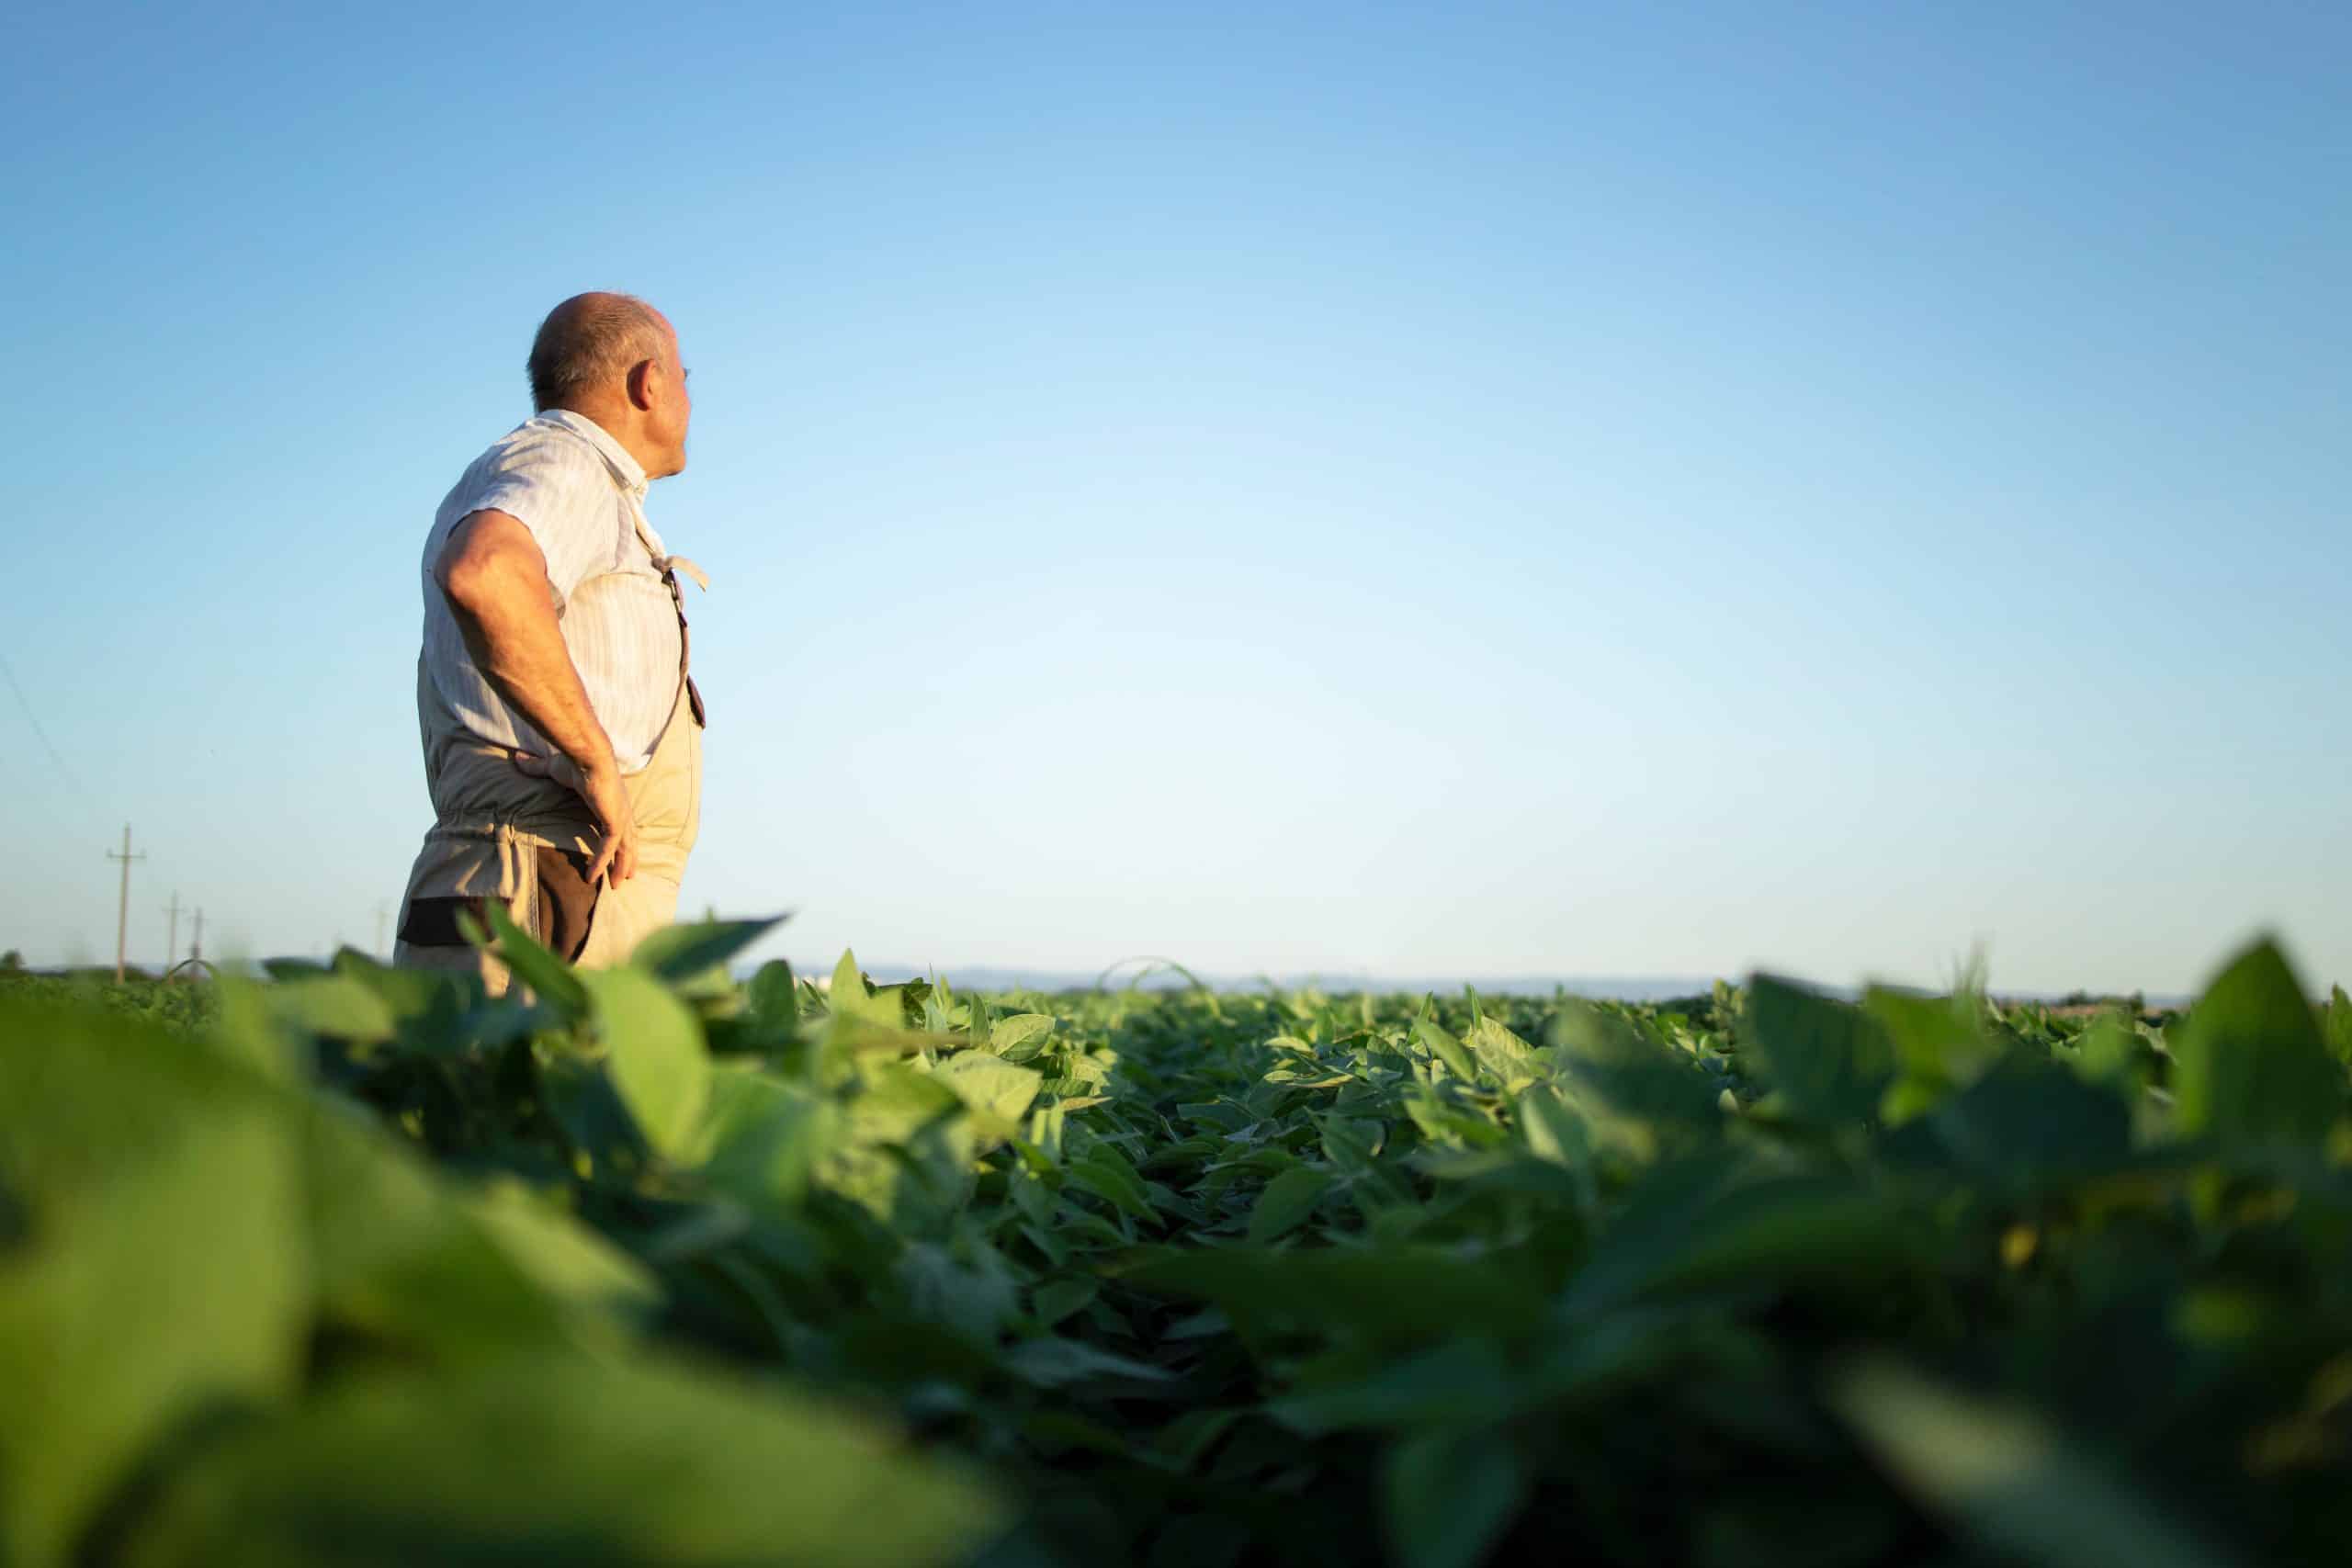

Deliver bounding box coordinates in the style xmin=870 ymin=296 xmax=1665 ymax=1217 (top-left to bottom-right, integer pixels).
xmin=119 ymin=1354 xmax=1009 ymax=1568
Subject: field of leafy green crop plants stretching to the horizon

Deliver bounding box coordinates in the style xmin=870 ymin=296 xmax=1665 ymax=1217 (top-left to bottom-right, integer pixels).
xmin=0 ymin=926 xmax=2352 ymax=1568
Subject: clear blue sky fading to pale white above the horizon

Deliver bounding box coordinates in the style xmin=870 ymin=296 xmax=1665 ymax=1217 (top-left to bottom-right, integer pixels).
xmin=0 ymin=0 xmax=2352 ymax=989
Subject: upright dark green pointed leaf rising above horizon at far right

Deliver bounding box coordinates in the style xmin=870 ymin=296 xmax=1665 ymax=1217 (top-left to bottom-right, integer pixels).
xmin=2168 ymin=941 xmax=2345 ymax=1147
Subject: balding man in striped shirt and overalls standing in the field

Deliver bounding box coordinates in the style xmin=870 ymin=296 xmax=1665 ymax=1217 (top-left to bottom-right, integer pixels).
xmin=393 ymin=294 xmax=703 ymax=992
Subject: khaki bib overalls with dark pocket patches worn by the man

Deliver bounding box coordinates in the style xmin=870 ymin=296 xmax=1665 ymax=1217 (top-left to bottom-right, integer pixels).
xmin=393 ymin=510 xmax=703 ymax=997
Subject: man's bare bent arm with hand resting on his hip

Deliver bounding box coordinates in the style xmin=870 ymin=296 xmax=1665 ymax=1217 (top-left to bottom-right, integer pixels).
xmin=433 ymin=510 xmax=638 ymax=882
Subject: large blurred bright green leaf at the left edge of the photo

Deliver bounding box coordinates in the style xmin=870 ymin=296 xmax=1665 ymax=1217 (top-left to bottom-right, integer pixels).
xmin=0 ymin=997 xmax=311 ymax=1568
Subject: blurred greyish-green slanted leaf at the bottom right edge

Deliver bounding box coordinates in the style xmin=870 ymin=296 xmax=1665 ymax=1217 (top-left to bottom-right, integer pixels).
xmin=1830 ymin=1361 xmax=2234 ymax=1568
